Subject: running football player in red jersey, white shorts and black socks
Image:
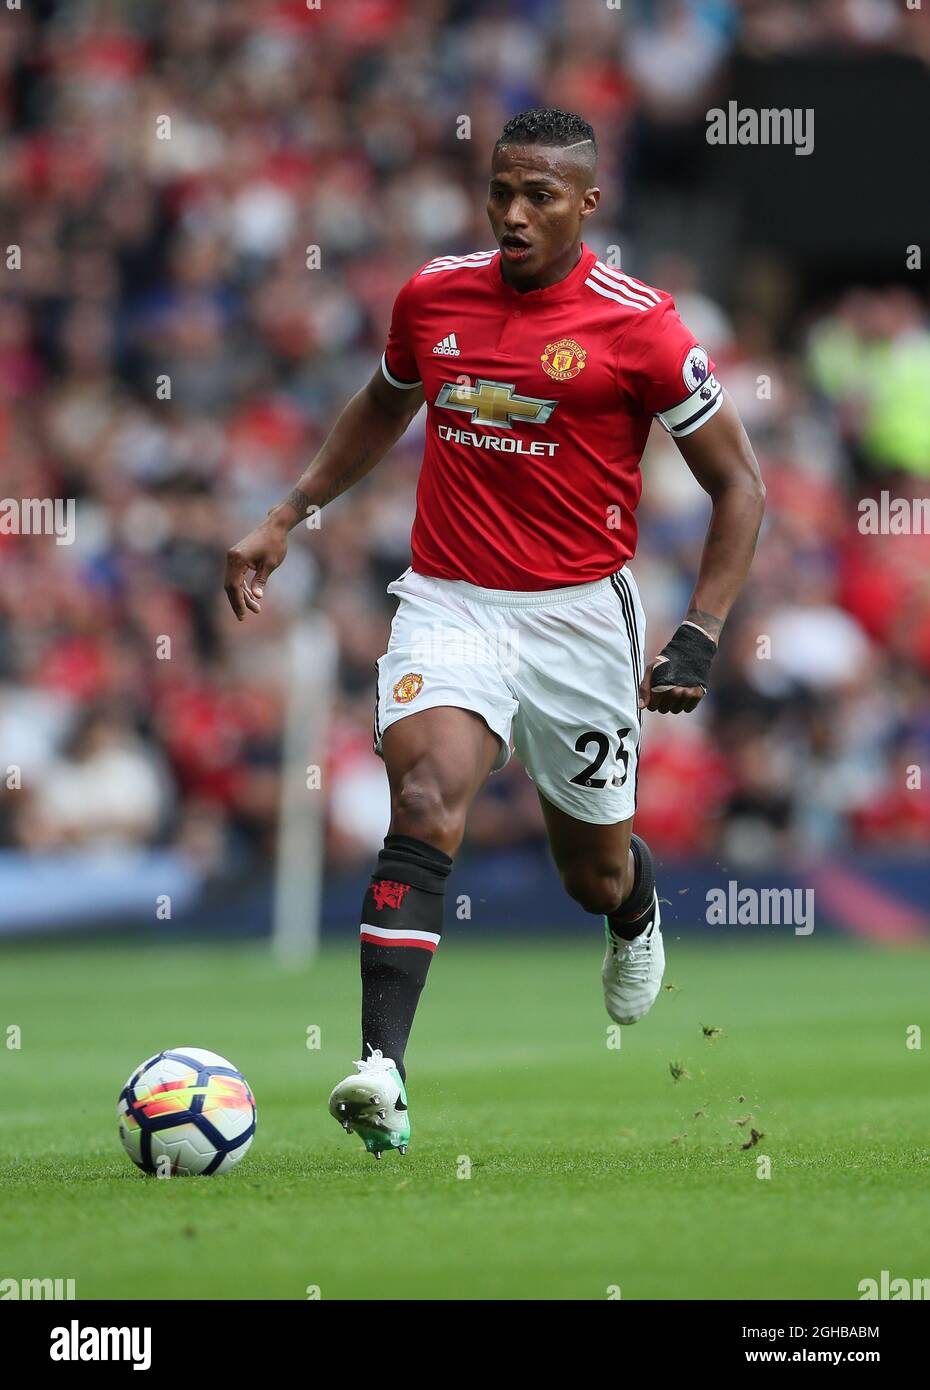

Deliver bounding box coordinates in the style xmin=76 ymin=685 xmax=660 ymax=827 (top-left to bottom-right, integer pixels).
xmin=225 ymin=110 xmax=765 ymax=1158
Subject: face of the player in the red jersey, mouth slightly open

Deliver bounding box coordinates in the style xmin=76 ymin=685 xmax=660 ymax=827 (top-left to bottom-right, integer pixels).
xmin=488 ymin=145 xmax=601 ymax=288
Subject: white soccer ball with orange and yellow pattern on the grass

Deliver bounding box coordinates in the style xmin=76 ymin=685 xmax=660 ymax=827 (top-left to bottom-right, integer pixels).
xmin=117 ymin=1047 xmax=256 ymax=1177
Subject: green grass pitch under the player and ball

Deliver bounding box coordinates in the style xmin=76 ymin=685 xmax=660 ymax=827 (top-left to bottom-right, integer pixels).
xmin=0 ymin=933 xmax=930 ymax=1300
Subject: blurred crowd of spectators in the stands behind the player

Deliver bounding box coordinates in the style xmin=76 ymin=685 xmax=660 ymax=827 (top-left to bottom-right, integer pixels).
xmin=0 ymin=0 xmax=930 ymax=876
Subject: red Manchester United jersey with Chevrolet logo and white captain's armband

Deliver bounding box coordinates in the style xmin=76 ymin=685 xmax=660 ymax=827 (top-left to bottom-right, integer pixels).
xmin=382 ymin=245 xmax=723 ymax=589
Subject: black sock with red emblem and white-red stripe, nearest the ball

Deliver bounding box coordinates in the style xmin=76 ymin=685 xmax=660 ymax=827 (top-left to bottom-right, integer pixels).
xmin=360 ymin=835 xmax=452 ymax=1077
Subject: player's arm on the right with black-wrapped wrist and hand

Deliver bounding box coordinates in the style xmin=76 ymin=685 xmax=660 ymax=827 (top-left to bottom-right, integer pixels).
xmin=639 ymin=395 xmax=766 ymax=714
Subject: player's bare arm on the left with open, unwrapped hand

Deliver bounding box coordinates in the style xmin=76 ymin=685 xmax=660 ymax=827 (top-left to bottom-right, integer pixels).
xmin=224 ymin=367 xmax=424 ymax=621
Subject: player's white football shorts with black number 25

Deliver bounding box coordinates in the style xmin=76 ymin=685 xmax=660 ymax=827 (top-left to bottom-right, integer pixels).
xmin=374 ymin=569 xmax=645 ymax=826
